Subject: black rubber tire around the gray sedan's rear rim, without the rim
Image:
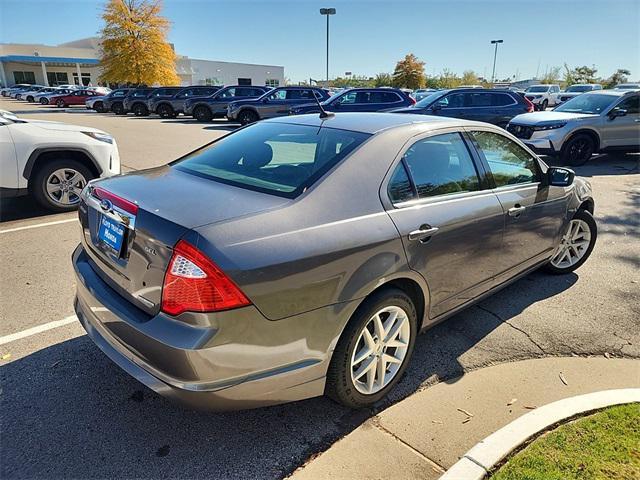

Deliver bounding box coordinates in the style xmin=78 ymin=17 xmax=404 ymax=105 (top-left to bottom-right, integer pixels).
xmin=325 ymin=288 xmax=418 ymax=408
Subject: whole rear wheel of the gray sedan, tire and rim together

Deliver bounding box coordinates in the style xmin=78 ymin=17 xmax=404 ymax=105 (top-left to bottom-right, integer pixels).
xmin=325 ymin=288 xmax=418 ymax=408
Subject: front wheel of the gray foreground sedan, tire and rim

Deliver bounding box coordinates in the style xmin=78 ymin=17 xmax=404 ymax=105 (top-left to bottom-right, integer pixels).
xmin=544 ymin=210 xmax=598 ymax=275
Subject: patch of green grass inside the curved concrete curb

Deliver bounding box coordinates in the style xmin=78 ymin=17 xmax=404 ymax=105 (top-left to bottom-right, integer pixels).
xmin=491 ymin=403 xmax=640 ymax=480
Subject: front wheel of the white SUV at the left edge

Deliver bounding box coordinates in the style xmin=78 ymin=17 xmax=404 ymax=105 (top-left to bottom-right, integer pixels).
xmin=29 ymin=158 xmax=95 ymax=212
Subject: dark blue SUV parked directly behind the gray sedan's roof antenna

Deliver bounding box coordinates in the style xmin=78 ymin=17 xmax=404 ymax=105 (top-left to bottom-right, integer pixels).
xmin=291 ymin=88 xmax=416 ymax=115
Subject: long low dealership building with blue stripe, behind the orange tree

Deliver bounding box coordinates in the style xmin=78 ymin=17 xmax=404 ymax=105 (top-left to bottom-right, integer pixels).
xmin=0 ymin=37 xmax=284 ymax=87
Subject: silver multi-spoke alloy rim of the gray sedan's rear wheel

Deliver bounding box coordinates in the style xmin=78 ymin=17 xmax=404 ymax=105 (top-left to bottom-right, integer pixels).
xmin=351 ymin=306 xmax=411 ymax=395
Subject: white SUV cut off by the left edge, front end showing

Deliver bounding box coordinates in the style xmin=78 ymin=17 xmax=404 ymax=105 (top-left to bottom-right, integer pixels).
xmin=0 ymin=110 xmax=120 ymax=212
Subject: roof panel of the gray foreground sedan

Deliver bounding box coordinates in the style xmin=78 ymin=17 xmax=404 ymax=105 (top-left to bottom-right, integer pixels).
xmin=263 ymin=112 xmax=486 ymax=134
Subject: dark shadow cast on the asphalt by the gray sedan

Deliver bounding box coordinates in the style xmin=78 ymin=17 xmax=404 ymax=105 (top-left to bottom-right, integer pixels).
xmin=0 ymin=273 xmax=578 ymax=479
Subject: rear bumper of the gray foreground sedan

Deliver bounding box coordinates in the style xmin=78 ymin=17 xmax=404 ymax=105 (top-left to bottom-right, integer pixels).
xmin=73 ymin=246 xmax=342 ymax=410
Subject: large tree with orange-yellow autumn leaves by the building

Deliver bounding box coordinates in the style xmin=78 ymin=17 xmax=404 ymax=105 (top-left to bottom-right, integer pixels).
xmin=100 ymin=0 xmax=180 ymax=85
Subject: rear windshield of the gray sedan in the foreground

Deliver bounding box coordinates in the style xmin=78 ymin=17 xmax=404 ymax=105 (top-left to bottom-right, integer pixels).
xmin=172 ymin=122 xmax=371 ymax=198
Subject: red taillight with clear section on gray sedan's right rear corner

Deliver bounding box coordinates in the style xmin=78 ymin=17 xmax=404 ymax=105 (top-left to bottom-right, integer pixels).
xmin=162 ymin=240 xmax=251 ymax=315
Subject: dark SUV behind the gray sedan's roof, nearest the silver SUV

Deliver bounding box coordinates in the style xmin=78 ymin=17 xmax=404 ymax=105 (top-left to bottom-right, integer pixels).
xmin=393 ymin=88 xmax=534 ymax=128
